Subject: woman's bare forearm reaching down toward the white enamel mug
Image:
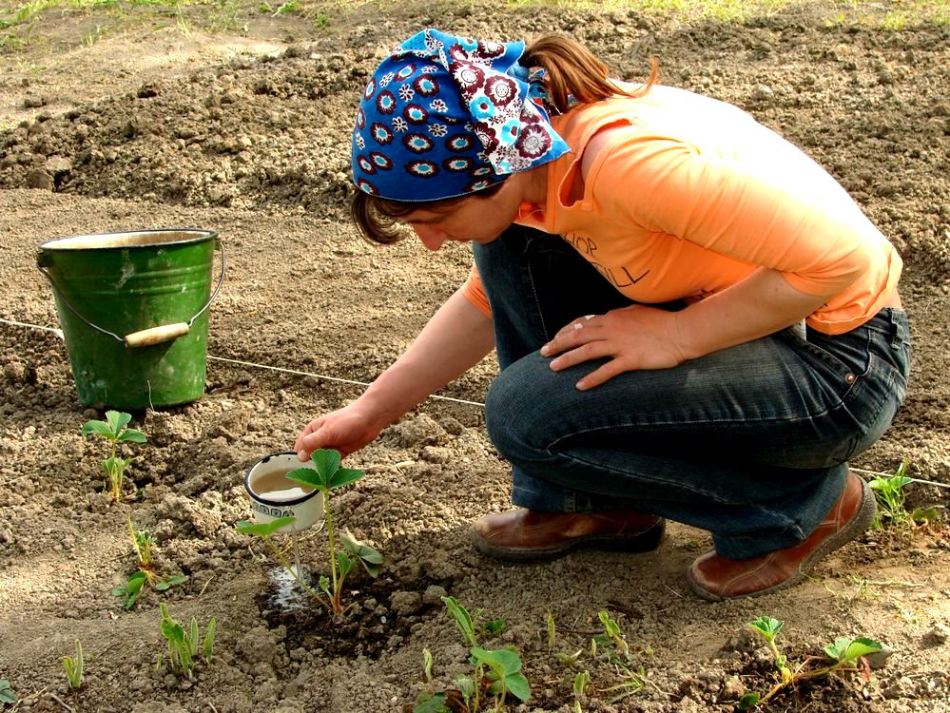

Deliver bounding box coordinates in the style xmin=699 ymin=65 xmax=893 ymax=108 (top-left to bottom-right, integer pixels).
xmin=359 ymin=291 xmax=495 ymax=425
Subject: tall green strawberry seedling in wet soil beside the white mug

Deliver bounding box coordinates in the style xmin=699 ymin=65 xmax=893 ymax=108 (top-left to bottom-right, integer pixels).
xmin=287 ymin=448 xmax=383 ymax=615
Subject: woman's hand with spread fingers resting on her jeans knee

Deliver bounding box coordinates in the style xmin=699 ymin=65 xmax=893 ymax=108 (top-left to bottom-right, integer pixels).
xmin=541 ymin=305 xmax=686 ymax=391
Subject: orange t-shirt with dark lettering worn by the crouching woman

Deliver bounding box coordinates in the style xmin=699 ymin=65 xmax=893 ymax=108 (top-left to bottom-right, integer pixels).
xmin=464 ymin=86 xmax=902 ymax=334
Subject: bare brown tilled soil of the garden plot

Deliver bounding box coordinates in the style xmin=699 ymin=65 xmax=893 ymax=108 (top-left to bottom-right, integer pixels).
xmin=0 ymin=2 xmax=950 ymax=713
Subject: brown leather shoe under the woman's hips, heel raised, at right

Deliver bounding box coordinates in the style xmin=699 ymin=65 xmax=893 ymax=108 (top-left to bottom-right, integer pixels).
xmin=687 ymin=473 xmax=877 ymax=601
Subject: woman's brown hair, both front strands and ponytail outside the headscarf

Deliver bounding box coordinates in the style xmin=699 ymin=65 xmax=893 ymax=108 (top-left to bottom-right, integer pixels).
xmin=350 ymin=35 xmax=659 ymax=245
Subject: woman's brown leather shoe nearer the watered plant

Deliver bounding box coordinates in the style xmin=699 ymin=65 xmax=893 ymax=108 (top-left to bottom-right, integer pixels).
xmin=472 ymin=509 xmax=665 ymax=562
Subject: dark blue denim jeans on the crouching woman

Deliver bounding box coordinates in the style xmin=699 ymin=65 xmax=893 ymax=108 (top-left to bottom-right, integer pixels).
xmin=474 ymin=226 xmax=911 ymax=559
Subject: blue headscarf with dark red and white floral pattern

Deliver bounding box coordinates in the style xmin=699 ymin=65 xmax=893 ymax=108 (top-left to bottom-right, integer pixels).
xmin=352 ymin=28 xmax=570 ymax=202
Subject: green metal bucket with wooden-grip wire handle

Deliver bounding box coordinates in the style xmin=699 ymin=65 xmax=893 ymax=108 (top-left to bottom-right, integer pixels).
xmin=36 ymin=228 xmax=224 ymax=409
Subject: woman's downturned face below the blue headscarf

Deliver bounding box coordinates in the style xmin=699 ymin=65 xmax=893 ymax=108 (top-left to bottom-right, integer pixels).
xmin=400 ymin=176 xmax=522 ymax=250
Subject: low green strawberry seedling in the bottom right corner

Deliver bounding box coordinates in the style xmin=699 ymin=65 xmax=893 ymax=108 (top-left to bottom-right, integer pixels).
xmin=737 ymin=616 xmax=883 ymax=710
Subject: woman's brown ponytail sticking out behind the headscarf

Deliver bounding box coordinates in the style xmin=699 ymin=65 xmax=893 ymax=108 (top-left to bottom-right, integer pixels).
xmin=520 ymin=35 xmax=659 ymax=114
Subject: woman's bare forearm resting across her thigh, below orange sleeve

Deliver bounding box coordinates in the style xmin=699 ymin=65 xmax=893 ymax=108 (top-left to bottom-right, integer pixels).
xmin=674 ymin=268 xmax=831 ymax=359
